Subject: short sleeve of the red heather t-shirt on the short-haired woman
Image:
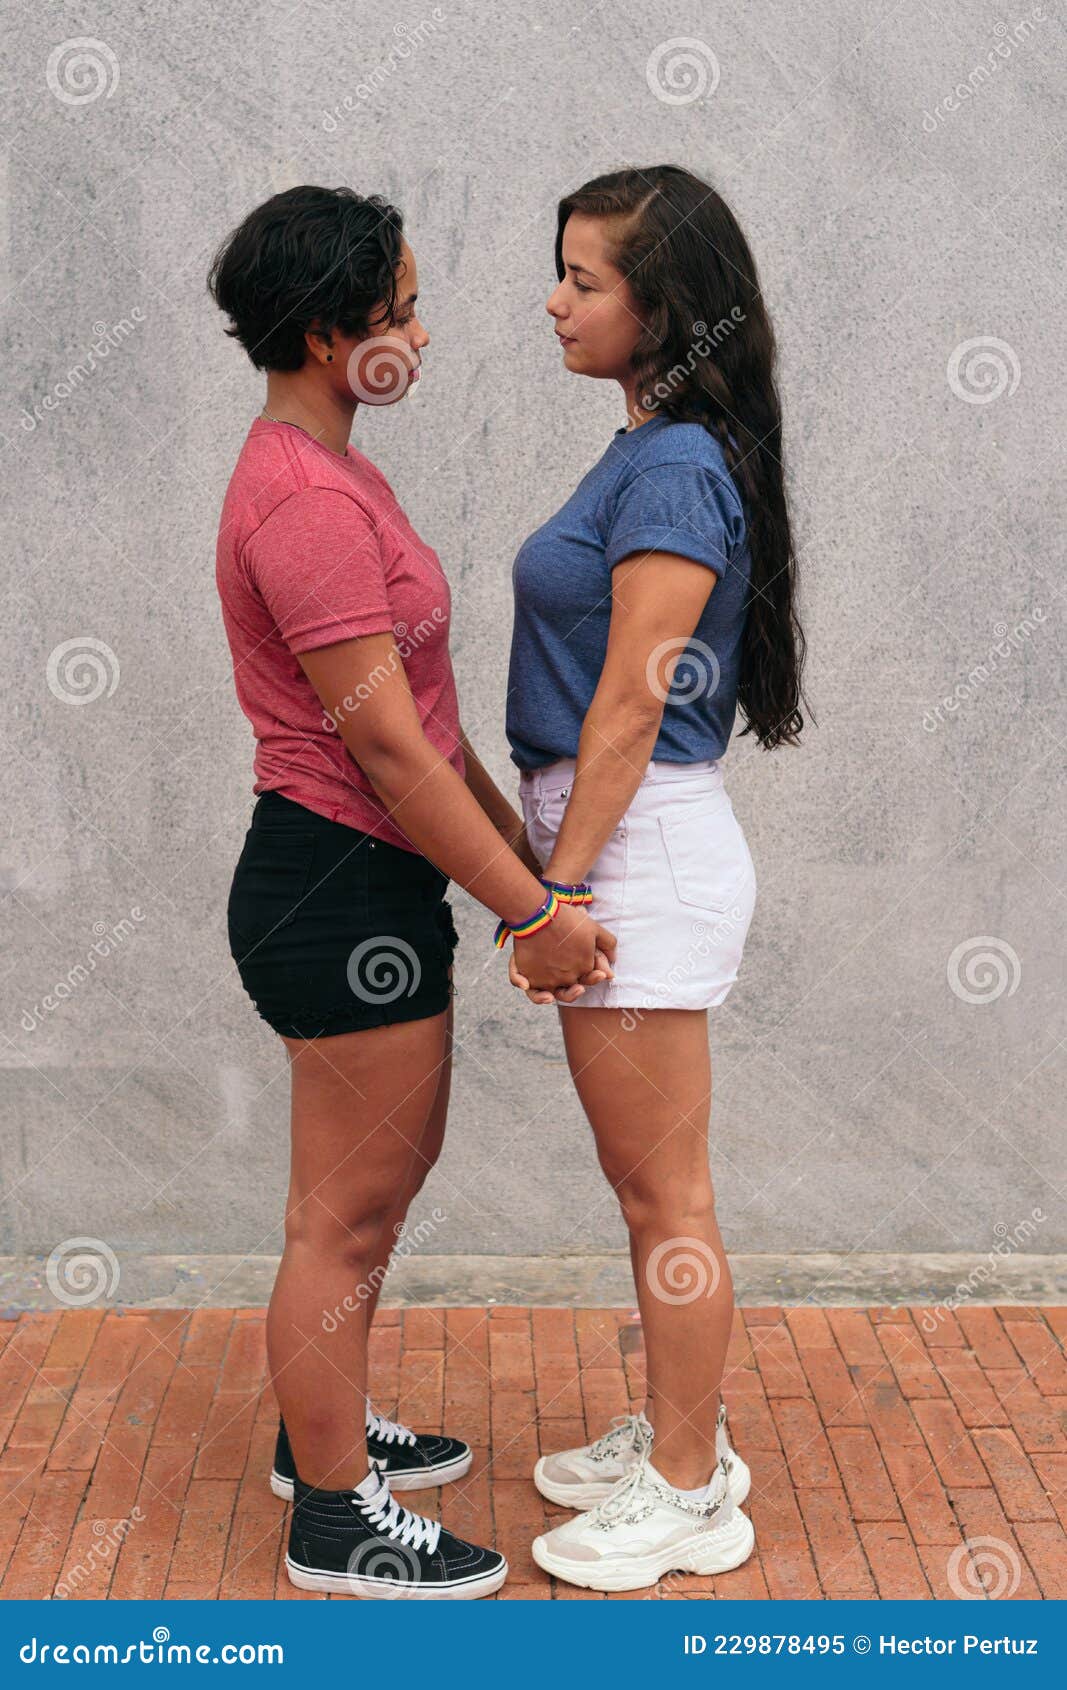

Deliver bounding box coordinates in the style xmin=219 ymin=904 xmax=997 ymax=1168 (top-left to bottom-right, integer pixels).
xmin=245 ymin=487 xmax=392 ymax=652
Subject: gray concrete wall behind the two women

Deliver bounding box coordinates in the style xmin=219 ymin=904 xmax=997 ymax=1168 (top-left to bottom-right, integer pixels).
xmin=0 ymin=0 xmax=1067 ymax=1259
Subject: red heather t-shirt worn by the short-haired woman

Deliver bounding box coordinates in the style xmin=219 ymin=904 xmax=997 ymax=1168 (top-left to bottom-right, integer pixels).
xmin=215 ymin=417 xmax=463 ymax=850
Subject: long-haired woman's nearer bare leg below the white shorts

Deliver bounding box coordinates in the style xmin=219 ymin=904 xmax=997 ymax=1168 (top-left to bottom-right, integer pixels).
xmin=560 ymin=1007 xmax=734 ymax=1491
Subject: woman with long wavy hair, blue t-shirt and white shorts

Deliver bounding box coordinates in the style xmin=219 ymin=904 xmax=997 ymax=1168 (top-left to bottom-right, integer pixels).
xmin=507 ymin=166 xmax=803 ymax=1590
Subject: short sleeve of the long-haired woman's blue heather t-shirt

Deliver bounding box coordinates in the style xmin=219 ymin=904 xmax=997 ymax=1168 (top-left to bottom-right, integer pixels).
xmin=605 ymin=463 xmax=744 ymax=576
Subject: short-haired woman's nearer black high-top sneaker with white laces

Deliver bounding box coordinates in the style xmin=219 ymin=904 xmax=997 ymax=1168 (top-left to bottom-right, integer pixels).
xmin=286 ymin=1467 xmax=507 ymax=1600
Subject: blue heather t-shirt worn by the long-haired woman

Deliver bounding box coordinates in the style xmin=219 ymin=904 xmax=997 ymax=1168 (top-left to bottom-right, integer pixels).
xmin=507 ymin=412 xmax=751 ymax=769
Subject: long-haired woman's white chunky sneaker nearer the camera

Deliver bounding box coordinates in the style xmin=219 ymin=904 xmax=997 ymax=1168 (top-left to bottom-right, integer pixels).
xmin=531 ymin=1452 xmax=756 ymax=1590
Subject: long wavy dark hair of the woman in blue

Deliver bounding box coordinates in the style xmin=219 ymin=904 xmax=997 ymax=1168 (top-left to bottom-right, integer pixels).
xmin=556 ymin=164 xmax=807 ymax=750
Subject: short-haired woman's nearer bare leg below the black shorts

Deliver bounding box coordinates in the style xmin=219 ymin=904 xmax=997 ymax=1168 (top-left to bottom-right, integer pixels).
xmin=267 ymin=1012 xmax=446 ymax=1491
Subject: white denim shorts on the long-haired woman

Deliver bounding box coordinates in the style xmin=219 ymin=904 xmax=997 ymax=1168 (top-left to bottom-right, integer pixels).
xmin=519 ymin=757 xmax=756 ymax=1009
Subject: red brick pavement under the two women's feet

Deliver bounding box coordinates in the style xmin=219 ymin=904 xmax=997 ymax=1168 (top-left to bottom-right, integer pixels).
xmin=0 ymin=1306 xmax=1067 ymax=1600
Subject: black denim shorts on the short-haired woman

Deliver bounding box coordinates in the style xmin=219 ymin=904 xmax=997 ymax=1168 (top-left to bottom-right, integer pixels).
xmin=227 ymin=793 xmax=457 ymax=1039
